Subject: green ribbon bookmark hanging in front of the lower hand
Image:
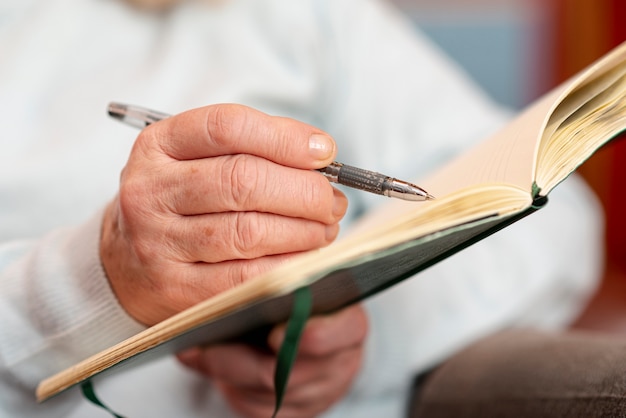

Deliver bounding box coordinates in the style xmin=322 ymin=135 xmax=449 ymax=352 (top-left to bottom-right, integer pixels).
xmin=272 ymin=287 xmax=313 ymax=418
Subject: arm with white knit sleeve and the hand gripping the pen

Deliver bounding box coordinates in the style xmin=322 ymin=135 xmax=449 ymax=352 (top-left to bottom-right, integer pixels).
xmin=0 ymin=105 xmax=346 ymax=416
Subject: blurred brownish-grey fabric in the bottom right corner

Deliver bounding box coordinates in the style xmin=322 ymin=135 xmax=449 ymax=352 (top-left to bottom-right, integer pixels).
xmin=409 ymin=330 xmax=626 ymax=418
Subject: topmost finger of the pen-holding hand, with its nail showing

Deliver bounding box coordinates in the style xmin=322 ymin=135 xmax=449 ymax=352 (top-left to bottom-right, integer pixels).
xmin=144 ymin=104 xmax=336 ymax=169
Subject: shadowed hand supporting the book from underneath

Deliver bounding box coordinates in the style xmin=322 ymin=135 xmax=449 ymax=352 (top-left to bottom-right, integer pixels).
xmin=178 ymin=305 xmax=367 ymax=418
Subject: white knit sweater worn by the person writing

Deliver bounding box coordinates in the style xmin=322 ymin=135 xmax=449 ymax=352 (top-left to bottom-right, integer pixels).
xmin=0 ymin=0 xmax=601 ymax=418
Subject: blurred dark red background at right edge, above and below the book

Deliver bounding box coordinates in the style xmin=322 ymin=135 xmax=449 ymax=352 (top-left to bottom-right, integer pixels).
xmin=553 ymin=0 xmax=626 ymax=332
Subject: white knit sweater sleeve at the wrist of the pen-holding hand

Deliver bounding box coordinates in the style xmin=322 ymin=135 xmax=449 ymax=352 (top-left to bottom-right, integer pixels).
xmin=0 ymin=214 xmax=143 ymax=417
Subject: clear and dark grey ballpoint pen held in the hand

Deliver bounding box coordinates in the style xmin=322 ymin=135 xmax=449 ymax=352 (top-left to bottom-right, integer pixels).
xmin=108 ymin=102 xmax=434 ymax=201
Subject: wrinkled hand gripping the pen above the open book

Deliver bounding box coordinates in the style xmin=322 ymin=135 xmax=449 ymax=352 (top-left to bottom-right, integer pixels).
xmin=100 ymin=105 xmax=347 ymax=325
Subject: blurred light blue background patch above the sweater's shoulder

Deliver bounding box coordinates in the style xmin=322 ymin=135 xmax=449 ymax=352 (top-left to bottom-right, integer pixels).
xmin=391 ymin=0 xmax=555 ymax=109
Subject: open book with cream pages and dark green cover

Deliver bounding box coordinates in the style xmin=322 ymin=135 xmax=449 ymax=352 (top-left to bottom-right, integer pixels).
xmin=37 ymin=43 xmax=626 ymax=401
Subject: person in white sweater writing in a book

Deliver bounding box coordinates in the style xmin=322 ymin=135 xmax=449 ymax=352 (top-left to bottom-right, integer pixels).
xmin=0 ymin=0 xmax=602 ymax=417
